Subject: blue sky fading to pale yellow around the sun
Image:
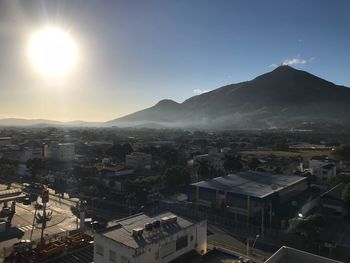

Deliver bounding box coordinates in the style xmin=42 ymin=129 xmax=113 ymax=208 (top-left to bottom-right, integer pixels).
xmin=0 ymin=0 xmax=350 ymax=121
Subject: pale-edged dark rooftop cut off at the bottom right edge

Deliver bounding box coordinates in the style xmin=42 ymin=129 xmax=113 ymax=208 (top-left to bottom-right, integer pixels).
xmin=265 ymin=246 xmax=342 ymax=263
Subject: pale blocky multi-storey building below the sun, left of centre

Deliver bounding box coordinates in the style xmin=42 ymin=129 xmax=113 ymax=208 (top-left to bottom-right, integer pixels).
xmin=44 ymin=143 xmax=75 ymax=162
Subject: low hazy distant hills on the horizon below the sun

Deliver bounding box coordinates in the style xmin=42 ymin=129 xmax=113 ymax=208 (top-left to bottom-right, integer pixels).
xmin=0 ymin=118 xmax=100 ymax=127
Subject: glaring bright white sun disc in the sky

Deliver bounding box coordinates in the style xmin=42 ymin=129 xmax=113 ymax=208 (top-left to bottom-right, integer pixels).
xmin=28 ymin=27 xmax=77 ymax=76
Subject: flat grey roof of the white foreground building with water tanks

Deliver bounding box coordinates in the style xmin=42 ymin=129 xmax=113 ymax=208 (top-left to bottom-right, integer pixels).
xmin=100 ymin=212 xmax=194 ymax=249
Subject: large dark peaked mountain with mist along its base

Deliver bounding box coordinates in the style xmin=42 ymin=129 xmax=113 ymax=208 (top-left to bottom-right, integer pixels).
xmin=105 ymin=66 xmax=350 ymax=129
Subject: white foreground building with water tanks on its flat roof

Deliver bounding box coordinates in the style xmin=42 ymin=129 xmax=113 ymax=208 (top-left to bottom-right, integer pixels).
xmin=94 ymin=212 xmax=207 ymax=263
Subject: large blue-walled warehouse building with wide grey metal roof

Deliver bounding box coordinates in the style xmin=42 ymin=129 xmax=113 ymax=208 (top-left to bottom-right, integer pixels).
xmin=189 ymin=172 xmax=307 ymax=224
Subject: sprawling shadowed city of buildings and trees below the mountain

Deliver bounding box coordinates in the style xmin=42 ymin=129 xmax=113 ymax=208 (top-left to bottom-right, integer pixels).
xmin=0 ymin=127 xmax=350 ymax=262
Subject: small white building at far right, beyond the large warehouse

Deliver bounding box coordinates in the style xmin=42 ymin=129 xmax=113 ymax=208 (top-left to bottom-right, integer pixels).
xmin=309 ymin=156 xmax=337 ymax=184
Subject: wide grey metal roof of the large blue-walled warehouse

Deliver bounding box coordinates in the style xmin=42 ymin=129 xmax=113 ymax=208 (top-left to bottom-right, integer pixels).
xmin=192 ymin=171 xmax=306 ymax=198
